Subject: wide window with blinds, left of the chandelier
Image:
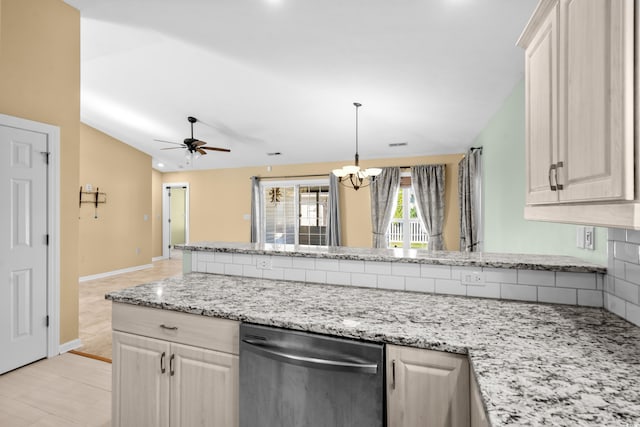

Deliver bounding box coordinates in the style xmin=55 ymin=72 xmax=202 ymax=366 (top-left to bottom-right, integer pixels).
xmin=262 ymin=182 xmax=329 ymax=245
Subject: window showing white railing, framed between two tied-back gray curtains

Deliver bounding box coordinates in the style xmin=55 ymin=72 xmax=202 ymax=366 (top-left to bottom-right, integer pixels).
xmin=387 ymin=177 xmax=429 ymax=249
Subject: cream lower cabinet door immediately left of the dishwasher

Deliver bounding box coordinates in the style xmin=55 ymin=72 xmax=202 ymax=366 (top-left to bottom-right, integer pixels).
xmin=171 ymin=344 xmax=238 ymax=427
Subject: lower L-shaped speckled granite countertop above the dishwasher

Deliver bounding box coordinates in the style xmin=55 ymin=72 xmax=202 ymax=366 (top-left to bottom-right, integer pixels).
xmin=107 ymin=273 xmax=640 ymax=427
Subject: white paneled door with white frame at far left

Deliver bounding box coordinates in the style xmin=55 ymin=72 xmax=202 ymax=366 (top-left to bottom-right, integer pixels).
xmin=0 ymin=114 xmax=60 ymax=373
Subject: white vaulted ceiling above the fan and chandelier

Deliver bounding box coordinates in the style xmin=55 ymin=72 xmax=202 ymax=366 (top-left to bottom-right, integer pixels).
xmin=66 ymin=0 xmax=537 ymax=171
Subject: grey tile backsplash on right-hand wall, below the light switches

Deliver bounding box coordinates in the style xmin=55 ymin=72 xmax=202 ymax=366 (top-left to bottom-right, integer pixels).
xmin=604 ymin=228 xmax=640 ymax=326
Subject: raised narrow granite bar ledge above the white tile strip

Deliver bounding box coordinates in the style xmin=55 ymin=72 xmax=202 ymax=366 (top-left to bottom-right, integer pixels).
xmin=176 ymin=242 xmax=606 ymax=273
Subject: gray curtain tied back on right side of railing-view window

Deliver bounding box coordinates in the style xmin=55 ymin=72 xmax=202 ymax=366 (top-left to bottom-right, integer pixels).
xmin=411 ymin=165 xmax=445 ymax=251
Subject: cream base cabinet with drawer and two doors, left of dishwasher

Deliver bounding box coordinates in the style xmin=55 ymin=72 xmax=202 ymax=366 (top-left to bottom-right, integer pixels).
xmin=112 ymin=303 xmax=238 ymax=427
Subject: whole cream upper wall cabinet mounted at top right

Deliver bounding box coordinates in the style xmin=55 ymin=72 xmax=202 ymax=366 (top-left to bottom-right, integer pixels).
xmin=518 ymin=0 xmax=640 ymax=228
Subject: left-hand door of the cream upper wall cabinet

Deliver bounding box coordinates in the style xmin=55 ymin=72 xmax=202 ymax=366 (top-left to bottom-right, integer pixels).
xmin=525 ymin=1 xmax=559 ymax=204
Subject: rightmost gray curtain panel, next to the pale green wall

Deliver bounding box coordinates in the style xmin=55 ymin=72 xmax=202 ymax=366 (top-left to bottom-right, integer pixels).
xmin=458 ymin=149 xmax=482 ymax=252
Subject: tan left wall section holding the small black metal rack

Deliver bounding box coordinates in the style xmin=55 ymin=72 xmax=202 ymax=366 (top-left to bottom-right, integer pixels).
xmin=79 ymin=124 xmax=152 ymax=276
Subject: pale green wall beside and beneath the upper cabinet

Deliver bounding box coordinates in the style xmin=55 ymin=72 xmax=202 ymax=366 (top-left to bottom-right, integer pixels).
xmin=473 ymin=80 xmax=607 ymax=265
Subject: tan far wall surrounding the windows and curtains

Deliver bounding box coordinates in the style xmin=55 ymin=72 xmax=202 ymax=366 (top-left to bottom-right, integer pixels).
xmin=163 ymin=154 xmax=463 ymax=250
